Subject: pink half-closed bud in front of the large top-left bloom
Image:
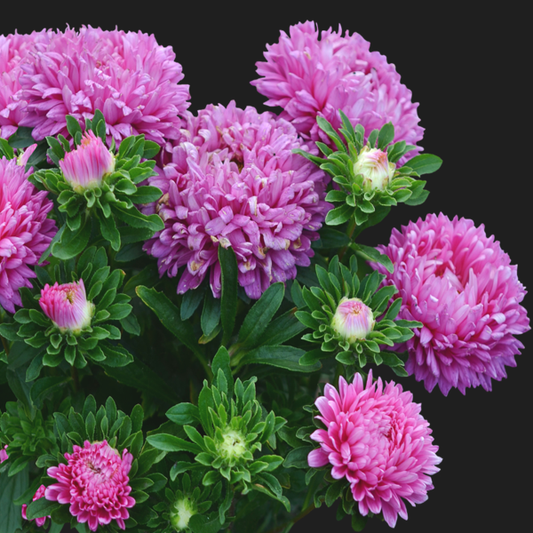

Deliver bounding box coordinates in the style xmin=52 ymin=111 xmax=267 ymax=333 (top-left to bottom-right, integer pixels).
xmin=59 ymin=130 xmax=115 ymax=193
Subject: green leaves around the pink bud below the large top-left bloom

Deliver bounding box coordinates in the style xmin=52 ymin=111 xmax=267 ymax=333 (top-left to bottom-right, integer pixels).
xmin=30 ymin=110 xmax=164 ymax=259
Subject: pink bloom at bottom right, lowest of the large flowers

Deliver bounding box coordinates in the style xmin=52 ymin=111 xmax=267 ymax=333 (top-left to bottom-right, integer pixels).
xmin=308 ymin=371 xmax=442 ymax=527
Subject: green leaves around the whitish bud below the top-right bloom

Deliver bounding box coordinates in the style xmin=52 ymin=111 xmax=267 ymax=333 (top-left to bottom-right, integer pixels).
xmin=298 ymin=111 xmax=442 ymax=235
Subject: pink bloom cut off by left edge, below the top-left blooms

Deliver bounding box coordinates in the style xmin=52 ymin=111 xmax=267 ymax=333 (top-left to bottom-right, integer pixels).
xmin=0 ymin=157 xmax=57 ymax=313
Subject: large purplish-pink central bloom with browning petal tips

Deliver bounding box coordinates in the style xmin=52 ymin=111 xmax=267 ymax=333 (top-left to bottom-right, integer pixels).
xmin=145 ymin=102 xmax=330 ymax=299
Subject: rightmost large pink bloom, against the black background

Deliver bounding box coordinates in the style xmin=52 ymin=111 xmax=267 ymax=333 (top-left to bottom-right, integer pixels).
xmin=374 ymin=213 xmax=530 ymax=395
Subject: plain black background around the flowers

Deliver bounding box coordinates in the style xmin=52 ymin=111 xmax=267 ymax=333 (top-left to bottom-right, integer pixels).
xmin=0 ymin=1 xmax=533 ymax=533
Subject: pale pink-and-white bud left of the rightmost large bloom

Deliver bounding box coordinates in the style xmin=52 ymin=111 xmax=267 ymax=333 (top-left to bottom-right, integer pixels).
xmin=331 ymin=298 xmax=375 ymax=344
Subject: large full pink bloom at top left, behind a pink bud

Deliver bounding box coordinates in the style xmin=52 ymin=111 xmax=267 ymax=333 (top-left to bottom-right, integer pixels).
xmin=17 ymin=26 xmax=189 ymax=144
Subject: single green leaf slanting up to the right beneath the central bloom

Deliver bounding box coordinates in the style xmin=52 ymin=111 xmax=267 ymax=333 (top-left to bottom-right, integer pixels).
xmin=239 ymin=282 xmax=285 ymax=347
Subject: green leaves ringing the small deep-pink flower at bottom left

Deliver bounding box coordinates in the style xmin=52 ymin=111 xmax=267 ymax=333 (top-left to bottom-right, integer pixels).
xmin=23 ymin=395 xmax=167 ymax=532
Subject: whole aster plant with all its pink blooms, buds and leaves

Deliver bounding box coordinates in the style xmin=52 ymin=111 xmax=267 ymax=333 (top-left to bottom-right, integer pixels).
xmin=0 ymin=21 xmax=529 ymax=533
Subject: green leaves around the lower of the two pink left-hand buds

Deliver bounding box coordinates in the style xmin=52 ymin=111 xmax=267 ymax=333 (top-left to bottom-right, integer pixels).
xmin=0 ymin=246 xmax=140 ymax=374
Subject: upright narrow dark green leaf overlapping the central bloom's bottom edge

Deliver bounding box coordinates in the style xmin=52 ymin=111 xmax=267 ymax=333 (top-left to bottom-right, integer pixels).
xmin=219 ymin=246 xmax=238 ymax=344
